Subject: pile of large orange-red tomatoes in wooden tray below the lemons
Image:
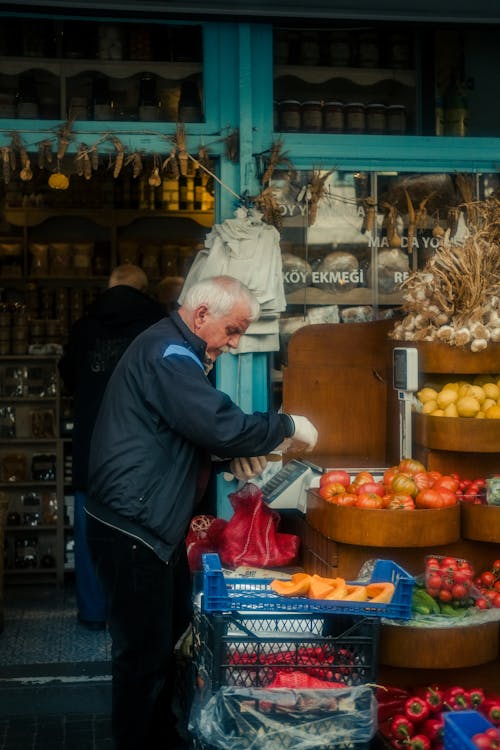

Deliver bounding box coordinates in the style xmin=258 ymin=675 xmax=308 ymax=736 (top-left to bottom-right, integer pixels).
xmin=319 ymin=458 xmax=460 ymax=510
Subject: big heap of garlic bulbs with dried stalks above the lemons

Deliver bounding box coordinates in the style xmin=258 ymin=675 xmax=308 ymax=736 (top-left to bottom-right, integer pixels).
xmin=390 ymin=197 xmax=500 ymax=352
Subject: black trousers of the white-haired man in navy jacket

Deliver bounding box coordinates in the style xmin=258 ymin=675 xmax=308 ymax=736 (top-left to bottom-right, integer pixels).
xmin=87 ymin=516 xmax=191 ymax=750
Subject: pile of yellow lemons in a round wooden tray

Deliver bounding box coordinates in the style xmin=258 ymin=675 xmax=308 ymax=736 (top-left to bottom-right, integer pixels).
xmin=417 ymin=375 xmax=500 ymax=419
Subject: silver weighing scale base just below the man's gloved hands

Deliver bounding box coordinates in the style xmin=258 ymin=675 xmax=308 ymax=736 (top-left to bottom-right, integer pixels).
xmin=260 ymin=458 xmax=323 ymax=514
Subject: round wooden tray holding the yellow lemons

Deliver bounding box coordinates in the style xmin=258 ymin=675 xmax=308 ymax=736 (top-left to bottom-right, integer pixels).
xmin=413 ymin=414 xmax=500 ymax=453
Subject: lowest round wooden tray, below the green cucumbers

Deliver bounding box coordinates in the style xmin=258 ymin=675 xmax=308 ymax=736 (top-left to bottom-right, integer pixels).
xmin=379 ymin=622 xmax=500 ymax=669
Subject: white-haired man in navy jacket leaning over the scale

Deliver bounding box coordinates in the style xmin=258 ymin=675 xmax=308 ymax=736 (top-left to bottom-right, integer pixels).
xmin=86 ymin=276 xmax=317 ymax=750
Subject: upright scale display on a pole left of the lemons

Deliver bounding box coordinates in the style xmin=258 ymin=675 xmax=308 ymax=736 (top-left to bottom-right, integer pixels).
xmin=392 ymin=346 xmax=418 ymax=460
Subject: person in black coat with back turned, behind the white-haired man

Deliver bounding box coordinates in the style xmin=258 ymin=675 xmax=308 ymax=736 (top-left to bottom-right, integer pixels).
xmin=59 ymin=264 xmax=165 ymax=630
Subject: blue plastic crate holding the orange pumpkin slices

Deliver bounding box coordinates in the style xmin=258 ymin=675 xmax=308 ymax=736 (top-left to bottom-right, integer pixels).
xmin=202 ymin=552 xmax=415 ymax=620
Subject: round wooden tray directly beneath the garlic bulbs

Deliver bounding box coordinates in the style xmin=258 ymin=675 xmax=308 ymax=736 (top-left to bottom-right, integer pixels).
xmin=393 ymin=341 xmax=500 ymax=375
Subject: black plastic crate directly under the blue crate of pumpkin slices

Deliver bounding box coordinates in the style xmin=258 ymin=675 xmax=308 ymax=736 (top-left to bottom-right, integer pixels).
xmin=193 ymin=608 xmax=380 ymax=691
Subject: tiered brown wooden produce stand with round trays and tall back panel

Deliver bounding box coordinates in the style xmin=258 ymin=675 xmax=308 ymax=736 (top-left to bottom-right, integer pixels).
xmin=283 ymin=321 xmax=500 ymax=692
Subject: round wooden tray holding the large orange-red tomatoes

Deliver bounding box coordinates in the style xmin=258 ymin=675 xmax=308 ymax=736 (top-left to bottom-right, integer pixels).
xmin=306 ymin=490 xmax=460 ymax=547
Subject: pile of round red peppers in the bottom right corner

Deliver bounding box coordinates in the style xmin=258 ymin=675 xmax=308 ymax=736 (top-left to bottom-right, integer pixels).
xmin=376 ymin=685 xmax=500 ymax=750
